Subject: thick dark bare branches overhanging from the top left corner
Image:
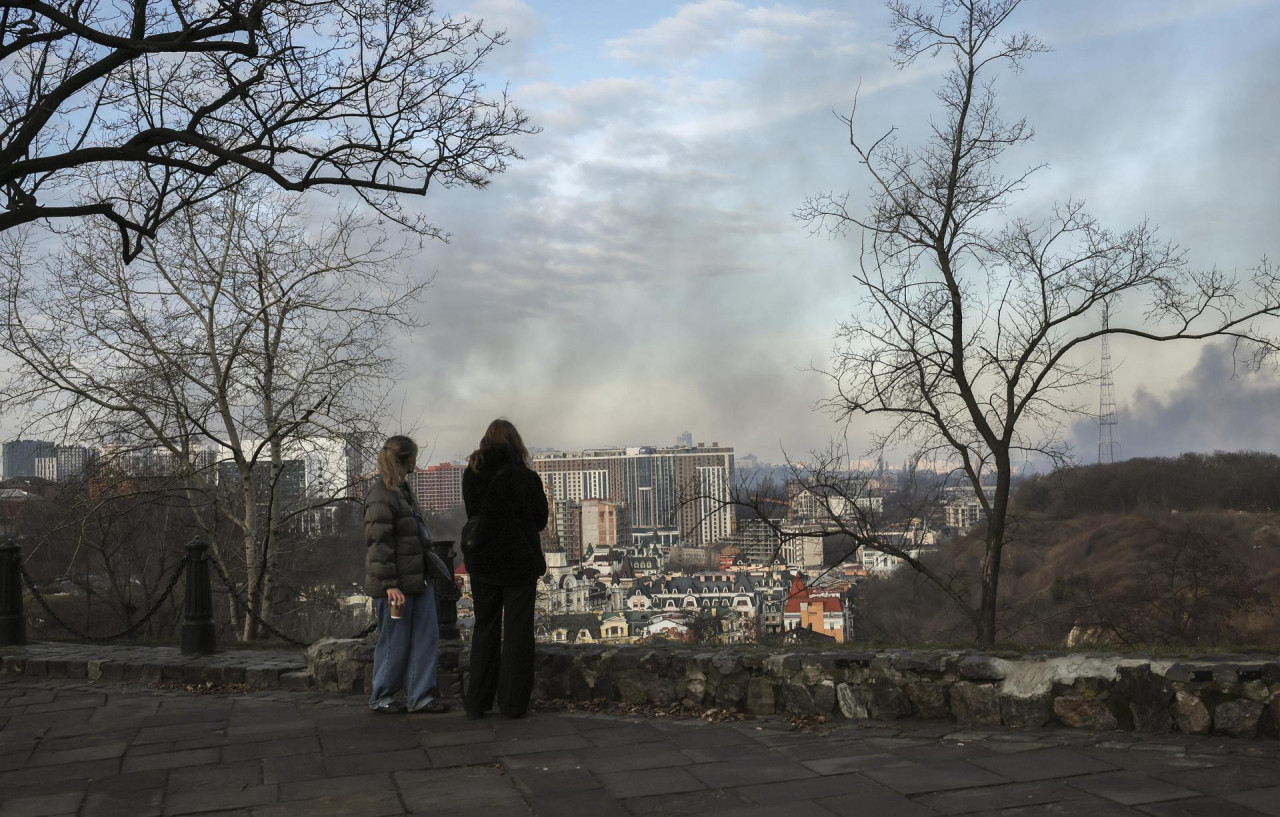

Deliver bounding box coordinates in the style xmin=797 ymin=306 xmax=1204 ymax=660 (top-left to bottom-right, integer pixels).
xmin=0 ymin=0 xmax=535 ymax=260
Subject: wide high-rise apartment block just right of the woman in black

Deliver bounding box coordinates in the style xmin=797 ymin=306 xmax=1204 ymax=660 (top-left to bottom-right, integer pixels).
xmin=532 ymin=443 xmax=733 ymax=546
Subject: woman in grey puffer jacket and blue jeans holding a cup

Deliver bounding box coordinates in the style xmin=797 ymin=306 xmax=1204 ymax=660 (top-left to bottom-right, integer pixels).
xmin=365 ymin=435 xmax=449 ymax=715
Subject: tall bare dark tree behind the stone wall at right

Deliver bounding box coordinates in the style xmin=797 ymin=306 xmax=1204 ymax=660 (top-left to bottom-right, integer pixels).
xmin=796 ymin=0 xmax=1280 ymax=644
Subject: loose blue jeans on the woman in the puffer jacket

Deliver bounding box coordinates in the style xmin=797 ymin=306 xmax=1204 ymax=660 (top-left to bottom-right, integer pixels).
xmin=369 ymin=584 xmax=440 ymax=712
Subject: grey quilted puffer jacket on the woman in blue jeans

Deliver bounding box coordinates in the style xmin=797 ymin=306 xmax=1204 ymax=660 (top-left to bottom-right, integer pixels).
xmin=365 ymin=479 xmax=426 ymax=598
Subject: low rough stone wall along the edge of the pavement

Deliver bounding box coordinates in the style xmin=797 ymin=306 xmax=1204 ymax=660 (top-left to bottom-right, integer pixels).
xmin=307 ymin=640 xmax=1280 ymax=738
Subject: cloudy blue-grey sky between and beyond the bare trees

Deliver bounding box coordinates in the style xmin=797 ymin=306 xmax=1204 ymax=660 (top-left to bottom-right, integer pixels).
xmin=7 ymin=0 xmax=1280 ymax=473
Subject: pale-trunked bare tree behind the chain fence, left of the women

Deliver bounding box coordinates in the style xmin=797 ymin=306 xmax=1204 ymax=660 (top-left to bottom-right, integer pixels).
xmin=0 ymin=177 xmax=426 ymax=638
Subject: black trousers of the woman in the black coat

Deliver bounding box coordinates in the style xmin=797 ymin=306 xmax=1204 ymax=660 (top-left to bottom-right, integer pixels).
xmin=463 ymin=578 xmax=538 ymax=717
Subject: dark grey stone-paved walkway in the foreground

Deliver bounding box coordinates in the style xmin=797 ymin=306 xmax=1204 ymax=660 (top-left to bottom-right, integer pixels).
xmin=0 ymin=677 xmax=1280 ymax=817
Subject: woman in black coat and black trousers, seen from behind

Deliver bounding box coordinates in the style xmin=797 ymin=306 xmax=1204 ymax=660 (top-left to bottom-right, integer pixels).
xmin=462 ymin=420 xmax=548 ymax=718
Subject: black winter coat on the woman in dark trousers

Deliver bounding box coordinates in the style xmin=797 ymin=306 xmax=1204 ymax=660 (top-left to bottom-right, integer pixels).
xmin=462 ymin=448 xmax=548 ymax=584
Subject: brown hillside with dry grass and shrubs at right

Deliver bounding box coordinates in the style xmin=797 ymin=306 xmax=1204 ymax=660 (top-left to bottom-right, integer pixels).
xmin=859 ymin=455 xmax=1280 ymax=649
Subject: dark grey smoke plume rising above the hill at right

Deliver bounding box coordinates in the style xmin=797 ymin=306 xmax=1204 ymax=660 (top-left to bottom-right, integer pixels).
xmin=1073 ymin=343 xmax=1280 ymax=465
